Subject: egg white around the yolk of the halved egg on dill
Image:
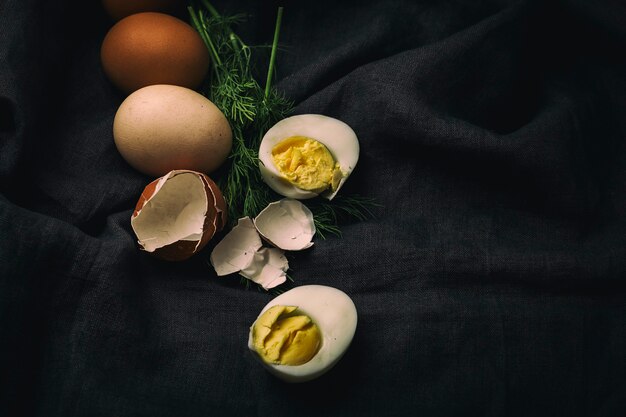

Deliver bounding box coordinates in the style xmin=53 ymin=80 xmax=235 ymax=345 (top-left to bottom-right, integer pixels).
xmin=259 ymin=114 xmax=360 ymax=200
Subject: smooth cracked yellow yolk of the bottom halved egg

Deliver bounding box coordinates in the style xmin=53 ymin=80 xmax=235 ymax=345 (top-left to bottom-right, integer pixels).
xmin=252 ymin=305 xmax=321 ymax=365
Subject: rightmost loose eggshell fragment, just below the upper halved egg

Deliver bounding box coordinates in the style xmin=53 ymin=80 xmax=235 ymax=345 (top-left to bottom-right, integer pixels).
xmin=254 ymin=198 xmax=315 ymax=251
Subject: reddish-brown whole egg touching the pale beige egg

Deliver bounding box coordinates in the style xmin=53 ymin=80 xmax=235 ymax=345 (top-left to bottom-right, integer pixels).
xmin=100 ymin=12 xmax=209 ymax=93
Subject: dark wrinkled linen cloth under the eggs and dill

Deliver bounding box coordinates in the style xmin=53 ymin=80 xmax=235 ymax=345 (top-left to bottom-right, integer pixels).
xmin=0 ymin=0 xmax=626 ymax=417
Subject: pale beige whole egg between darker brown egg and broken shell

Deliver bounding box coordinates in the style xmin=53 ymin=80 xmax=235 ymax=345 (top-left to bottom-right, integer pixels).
xmin=113 ymin=84 xmax=232 ymax=177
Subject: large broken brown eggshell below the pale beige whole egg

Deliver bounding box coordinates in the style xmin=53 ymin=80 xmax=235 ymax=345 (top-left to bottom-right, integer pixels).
xmin=131 ymin=170 xmax=227 ymax=261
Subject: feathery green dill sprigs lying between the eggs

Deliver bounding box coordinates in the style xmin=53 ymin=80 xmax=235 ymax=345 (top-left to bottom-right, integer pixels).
xmin=188 ymin=0 xmax=376 ymax=238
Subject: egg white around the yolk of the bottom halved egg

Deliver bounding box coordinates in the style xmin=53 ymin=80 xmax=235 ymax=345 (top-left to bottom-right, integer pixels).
xmin=248 ymin=285 xmax=357 ymax=382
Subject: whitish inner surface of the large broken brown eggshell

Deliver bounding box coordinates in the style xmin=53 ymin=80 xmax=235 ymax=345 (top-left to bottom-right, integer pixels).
xmin=131 ymin=173 xmax=208 ymax=252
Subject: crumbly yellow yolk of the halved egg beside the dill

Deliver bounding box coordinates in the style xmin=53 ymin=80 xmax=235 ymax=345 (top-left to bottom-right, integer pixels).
xmin=272 ymin=136 xmax=342 ymax=192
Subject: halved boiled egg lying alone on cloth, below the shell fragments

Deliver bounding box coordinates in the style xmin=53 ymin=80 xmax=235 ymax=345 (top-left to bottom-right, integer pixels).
xmin=248 ymin=285 xmax=357 ymax=382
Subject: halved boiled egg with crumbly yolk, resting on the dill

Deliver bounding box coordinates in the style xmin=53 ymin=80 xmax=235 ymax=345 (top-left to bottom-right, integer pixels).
xmin=259 ymin=114 xmax=360 ymax=200
